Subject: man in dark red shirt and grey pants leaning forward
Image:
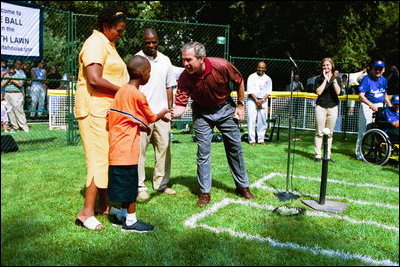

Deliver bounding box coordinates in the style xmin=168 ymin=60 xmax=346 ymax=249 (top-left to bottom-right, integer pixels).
xmin=173 ymin=42 xmax=254 ymax=207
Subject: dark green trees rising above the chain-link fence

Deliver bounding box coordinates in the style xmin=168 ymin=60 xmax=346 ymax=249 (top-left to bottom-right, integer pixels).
xmin=30 ymin=1 xmax=399 ymax=72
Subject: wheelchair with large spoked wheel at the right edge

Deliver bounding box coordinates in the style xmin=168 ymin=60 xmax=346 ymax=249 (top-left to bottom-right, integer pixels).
xmin=360 ymin=108 xmax=399 ymax=165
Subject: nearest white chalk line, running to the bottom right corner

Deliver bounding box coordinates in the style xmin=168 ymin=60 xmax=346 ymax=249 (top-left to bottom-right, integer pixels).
xmin=197 ymin=224 xmax=399 ymax=266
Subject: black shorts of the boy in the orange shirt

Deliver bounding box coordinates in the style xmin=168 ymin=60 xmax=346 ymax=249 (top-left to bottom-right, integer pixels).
xmin=107 ymin=165 xmax=139 ymax=203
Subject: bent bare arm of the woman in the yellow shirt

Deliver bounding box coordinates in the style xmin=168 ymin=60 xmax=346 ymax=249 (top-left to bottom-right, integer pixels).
xmin=84 ymin=63 xmax=119 ymax=94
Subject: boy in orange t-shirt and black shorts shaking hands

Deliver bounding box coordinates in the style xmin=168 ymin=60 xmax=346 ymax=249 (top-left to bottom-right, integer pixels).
xmin=107 ymin=55 xmax=171 ymax=233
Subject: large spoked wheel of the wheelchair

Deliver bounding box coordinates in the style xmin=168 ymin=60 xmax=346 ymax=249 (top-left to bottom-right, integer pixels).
xmin=360 ymin=129 xmax=392 ymax=165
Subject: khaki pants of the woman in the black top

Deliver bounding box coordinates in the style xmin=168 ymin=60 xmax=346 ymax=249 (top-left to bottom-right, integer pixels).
xmin=314 ymin=105 xmax=338 ymax=159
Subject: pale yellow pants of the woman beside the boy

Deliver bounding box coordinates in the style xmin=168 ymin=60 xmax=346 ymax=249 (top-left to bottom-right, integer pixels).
xmin=78 ymin=114 xmax=109 ymax=189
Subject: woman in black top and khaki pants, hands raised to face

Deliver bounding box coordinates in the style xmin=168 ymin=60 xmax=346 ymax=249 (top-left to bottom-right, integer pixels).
xmin=314 ymin=57 xmax=342 ymax=162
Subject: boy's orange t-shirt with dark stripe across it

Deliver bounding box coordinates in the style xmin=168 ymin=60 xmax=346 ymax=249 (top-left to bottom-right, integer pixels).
xmin=107 ymin=84 xmax=157 ymax=166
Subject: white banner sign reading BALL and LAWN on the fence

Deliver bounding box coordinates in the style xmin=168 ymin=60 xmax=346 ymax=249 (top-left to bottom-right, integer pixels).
xmin=1 ymin=2 xmax=43 ymax=59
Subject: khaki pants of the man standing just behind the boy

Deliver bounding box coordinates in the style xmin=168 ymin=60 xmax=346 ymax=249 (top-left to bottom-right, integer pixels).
xmin=138 ymin=120 xmax=171 ymax=192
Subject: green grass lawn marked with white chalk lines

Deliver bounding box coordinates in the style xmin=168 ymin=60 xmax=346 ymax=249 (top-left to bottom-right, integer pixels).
xmin=1 ymin=130 xmax=399 ymax=266
